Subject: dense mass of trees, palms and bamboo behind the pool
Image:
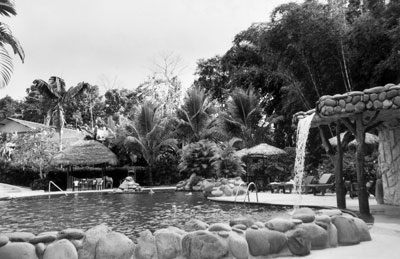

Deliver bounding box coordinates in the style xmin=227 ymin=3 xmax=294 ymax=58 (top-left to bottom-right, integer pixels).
xmin=0 ymin=0 xmax=400 ymax=191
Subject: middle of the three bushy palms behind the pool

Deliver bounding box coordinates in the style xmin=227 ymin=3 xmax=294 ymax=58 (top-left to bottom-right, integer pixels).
xmin=177 ymin=87 xmax=224 ymax=142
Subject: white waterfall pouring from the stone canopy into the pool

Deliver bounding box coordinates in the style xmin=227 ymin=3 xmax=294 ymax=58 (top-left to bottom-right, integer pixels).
xmin=293 ymin=113 xmax=314 ymax=210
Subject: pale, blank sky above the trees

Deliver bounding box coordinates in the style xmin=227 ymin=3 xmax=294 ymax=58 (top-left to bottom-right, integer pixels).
xmin=0 ymin=0 xmax=296 ymax=100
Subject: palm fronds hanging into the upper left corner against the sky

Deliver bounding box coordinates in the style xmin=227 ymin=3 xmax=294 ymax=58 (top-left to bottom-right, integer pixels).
xmin=0 ymin=0 xmax=25 ymax=88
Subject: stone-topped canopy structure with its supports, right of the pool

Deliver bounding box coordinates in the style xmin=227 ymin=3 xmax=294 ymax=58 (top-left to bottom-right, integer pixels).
xmin=294 ymin=84 xmax=400 ymax=215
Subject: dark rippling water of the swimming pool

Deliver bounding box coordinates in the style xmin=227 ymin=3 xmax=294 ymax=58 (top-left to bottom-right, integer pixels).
xmin=0 ymin=192 xmax=291 ymax=240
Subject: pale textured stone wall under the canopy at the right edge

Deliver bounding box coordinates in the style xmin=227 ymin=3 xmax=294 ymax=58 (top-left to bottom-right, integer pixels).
xmin=378 ymin=127 xmax=400 ymax=205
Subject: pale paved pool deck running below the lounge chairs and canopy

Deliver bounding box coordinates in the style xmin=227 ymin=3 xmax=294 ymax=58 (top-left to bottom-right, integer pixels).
xmin=209 ymin=192 xmax=400 ymax=259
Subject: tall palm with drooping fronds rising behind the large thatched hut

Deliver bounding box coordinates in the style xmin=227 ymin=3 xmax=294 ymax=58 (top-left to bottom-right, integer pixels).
xmin=33 ymin=76 xmax=90 ymax=151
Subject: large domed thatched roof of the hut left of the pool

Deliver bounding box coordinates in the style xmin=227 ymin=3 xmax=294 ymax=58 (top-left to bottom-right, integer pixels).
xmin=52 ymin=140 xmax=118 ymax=166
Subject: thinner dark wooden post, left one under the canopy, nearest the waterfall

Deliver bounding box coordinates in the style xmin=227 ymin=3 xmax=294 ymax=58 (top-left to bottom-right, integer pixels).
xmin=335 ymin=123 xmax=346 ymax=209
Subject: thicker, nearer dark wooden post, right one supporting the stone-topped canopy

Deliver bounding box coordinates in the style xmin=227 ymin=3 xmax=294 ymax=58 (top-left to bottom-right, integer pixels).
xmin=356 ymin=117 xmax=371 ymax=217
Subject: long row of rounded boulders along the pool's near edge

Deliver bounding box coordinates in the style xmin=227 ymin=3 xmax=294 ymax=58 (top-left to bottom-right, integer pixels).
xmin=0 ymin=208 xmax=371 ymax=259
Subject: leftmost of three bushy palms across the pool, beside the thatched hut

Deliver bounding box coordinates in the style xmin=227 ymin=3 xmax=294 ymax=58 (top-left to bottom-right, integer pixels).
xmin=124 ymin=101 xmax=177 ymax=185
